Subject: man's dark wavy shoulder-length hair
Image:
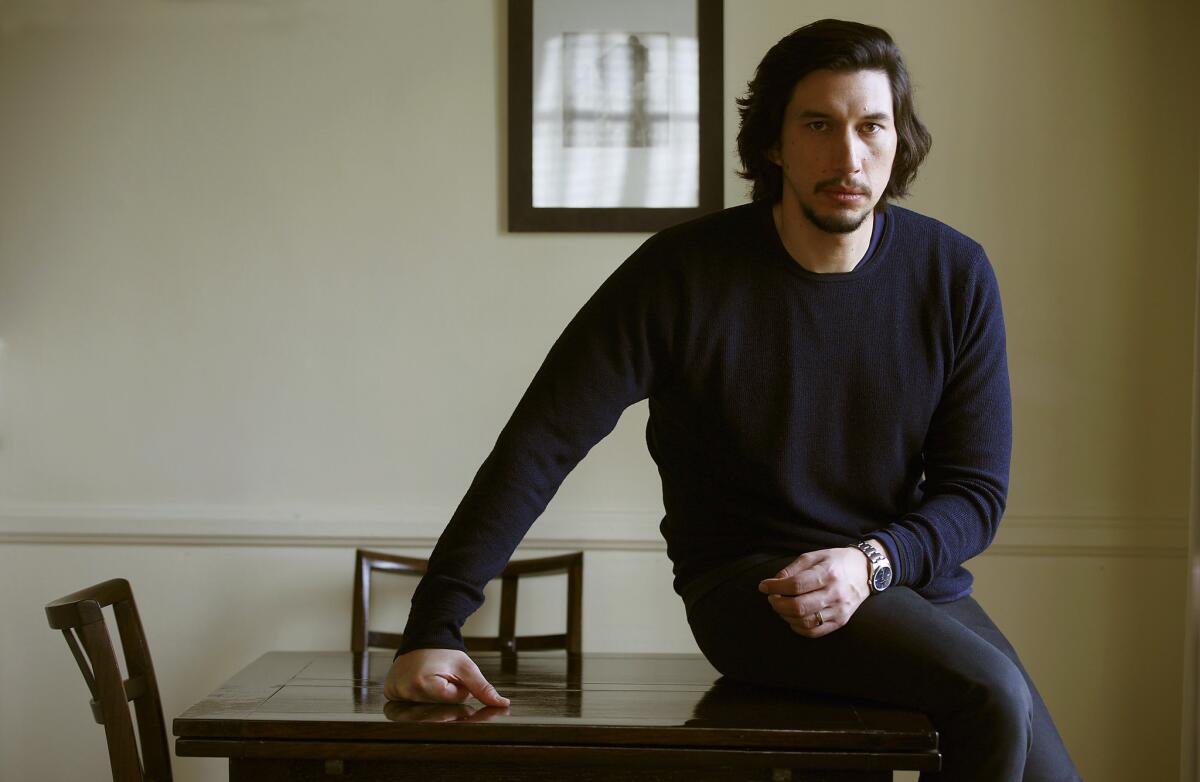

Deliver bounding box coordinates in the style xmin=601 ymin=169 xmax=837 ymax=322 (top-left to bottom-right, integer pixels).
xmin=738 ymin=19 xmax=934 ymax=207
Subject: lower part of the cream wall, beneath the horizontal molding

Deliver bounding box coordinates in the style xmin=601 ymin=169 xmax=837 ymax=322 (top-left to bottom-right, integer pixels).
xmin=0 ymin=543 xmax=1184 ymax=782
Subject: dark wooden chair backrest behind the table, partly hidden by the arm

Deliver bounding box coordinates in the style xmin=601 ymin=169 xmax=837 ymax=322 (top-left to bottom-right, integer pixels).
xmin=350 ymin=548 xmax=583 ymax=655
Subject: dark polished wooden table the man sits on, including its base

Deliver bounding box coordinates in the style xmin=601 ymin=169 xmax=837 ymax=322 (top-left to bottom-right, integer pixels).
xmin=174 ymin=651 xmax=940 ymax=782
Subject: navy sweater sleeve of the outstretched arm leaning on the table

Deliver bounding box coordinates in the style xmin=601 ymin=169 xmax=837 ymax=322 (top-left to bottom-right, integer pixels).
xmin=397 ymin=239 xmax=672 ymax=654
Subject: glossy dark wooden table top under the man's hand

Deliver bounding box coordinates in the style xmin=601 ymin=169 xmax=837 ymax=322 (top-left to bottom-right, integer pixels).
xmin=174 ymin=651 xmax=937 ymax=753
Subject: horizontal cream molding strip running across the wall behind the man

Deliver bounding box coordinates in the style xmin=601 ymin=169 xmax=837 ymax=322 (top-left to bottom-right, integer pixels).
xmin=0 ymin=504 xmax=1188 ymax=558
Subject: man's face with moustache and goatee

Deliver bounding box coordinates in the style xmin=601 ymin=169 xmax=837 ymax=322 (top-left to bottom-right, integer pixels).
xmin=767 ymin=71 xmax=896 ymax=234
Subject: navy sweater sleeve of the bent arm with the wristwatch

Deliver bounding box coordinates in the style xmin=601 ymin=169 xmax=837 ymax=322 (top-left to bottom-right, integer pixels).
xmin=878 ymin=249 xmax=1013 ymax=590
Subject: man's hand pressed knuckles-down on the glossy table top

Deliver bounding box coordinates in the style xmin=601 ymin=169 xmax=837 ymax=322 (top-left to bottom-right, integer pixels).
xmin=383 ymin=649 xmax=509 ymax=706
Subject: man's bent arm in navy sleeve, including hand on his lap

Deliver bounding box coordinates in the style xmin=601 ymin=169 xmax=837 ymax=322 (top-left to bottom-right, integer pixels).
xmin=760 ymin=249 xmax=1013 ymax=638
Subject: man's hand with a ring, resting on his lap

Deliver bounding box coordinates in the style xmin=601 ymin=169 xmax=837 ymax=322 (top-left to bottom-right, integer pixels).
xmin=758 ymin=547 xmax=871 ymax=638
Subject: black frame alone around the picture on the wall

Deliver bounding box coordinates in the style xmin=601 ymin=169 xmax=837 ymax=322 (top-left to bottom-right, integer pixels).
xmin=508 ymin=0 xmax=725 ymax=233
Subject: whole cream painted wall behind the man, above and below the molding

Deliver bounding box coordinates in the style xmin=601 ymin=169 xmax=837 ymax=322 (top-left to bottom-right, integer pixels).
xmin=0 ymin=0 xmax=1200 ymax=781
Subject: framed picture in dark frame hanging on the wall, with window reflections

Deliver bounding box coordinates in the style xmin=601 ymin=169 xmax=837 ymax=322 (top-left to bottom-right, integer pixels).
xmin=508 ymin=0 xmax=724 ymax=231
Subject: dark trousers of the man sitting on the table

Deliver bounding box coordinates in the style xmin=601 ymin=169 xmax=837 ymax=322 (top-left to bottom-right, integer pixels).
xmin=688 ymin=558 xmax=1079 ymax=782
